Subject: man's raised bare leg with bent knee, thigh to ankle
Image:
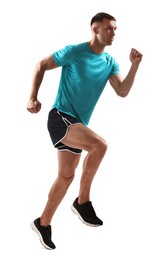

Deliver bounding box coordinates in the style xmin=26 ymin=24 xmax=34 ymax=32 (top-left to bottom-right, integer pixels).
xmin=63 ymin=124 xmax=107 ymax=204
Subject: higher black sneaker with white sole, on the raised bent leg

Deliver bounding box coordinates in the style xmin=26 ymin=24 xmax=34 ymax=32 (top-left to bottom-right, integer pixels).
xmin=71 ymin=198 xmax=103 ymax=227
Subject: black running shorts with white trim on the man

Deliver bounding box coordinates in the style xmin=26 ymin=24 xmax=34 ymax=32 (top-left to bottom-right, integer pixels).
xmin=47 ymin=108 xmax=82 ymax=154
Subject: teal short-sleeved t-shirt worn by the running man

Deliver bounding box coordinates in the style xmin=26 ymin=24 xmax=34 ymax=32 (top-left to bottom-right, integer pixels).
xmin=52 ymin=42 xmax=119 ymax=125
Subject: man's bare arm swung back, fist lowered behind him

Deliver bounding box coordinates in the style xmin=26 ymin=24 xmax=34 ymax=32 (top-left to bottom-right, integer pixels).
xmin=27 ymin=55 xmax=57 ymax=113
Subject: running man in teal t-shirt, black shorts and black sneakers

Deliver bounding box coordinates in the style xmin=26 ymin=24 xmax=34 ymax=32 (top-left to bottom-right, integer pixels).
xmin=27 ymin=13 xmax=142 ymax=249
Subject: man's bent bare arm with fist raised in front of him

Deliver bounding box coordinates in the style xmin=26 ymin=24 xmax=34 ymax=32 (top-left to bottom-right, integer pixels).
xmin=109 ymin=49 xmax=143 ymax=97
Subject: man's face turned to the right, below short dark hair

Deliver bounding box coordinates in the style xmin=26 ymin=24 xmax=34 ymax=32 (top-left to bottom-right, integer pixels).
xmin=96 ymin=19 xmax=117 ymax=46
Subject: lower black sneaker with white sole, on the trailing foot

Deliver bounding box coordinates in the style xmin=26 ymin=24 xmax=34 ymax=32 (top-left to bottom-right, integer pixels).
xmin=30 ymin=218 xmax=55 ymax=249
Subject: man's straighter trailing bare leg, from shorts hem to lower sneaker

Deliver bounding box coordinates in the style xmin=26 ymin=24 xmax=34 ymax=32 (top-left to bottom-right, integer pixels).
xmin=40 ymin=151 xmax=80 ymax=226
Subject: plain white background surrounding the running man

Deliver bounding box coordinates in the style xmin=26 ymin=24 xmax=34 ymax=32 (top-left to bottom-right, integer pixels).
xmin=0 ymin=0 xmax=168 ymax=260
